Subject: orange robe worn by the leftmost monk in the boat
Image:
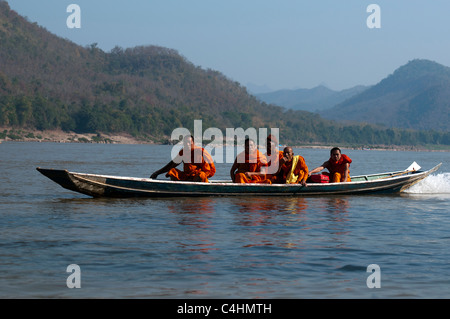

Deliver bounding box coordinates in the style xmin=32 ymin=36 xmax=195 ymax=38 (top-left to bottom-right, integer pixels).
xmin=166 ymin=146 xmax=216 ymax=183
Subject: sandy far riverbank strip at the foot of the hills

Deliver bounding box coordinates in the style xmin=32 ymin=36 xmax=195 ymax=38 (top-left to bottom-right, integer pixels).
xmin=0 ymin=127 xmax=450 ymax=152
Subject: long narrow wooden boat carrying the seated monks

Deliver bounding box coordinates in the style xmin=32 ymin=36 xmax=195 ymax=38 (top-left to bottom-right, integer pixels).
xmin=37 ymin=163 xmax=442 ymax=198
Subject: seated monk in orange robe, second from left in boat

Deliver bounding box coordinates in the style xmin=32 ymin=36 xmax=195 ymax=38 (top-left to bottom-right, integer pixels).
xmin=230 ymin=138 xmax=271 ymax=184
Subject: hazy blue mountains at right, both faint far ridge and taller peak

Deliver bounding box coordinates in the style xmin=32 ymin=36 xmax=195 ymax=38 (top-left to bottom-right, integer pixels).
xmin=256 ymin=59 xmax=450 ymax=132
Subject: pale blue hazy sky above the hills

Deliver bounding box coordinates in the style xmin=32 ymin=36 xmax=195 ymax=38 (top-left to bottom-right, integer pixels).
xmin=7 ymin=0 xmax=450 ymax=90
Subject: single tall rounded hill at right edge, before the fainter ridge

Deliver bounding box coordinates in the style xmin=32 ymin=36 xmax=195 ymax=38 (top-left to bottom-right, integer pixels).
xmin=321 ymin=59 xmax=450 ymax=132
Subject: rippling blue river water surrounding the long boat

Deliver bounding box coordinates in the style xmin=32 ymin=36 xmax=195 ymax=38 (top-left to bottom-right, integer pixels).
xmin=0 ymin=142 xmax=450 ymax=299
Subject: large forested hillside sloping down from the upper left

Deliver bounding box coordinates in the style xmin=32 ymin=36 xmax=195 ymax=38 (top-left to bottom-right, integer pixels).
xmin=0 ymin=1 xmax=450 ymax=145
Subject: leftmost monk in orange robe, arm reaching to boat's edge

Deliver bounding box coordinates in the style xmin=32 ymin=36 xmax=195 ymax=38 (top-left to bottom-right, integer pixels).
xmin=150 ymin=135 xmax=216 ymax=183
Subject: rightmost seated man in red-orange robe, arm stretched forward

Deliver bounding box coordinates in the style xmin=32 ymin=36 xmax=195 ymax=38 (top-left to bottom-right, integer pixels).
xmin=309 ymin=147 xmax=352 ymax=183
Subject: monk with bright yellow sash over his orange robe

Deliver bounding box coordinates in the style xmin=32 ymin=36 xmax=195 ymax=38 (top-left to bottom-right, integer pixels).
xmin=280 ymin=146 xmax=308 ymax=186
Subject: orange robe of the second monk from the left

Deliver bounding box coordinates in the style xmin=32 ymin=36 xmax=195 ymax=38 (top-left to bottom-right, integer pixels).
xmin=234 ymin=150 xmax=271 ymax=184
